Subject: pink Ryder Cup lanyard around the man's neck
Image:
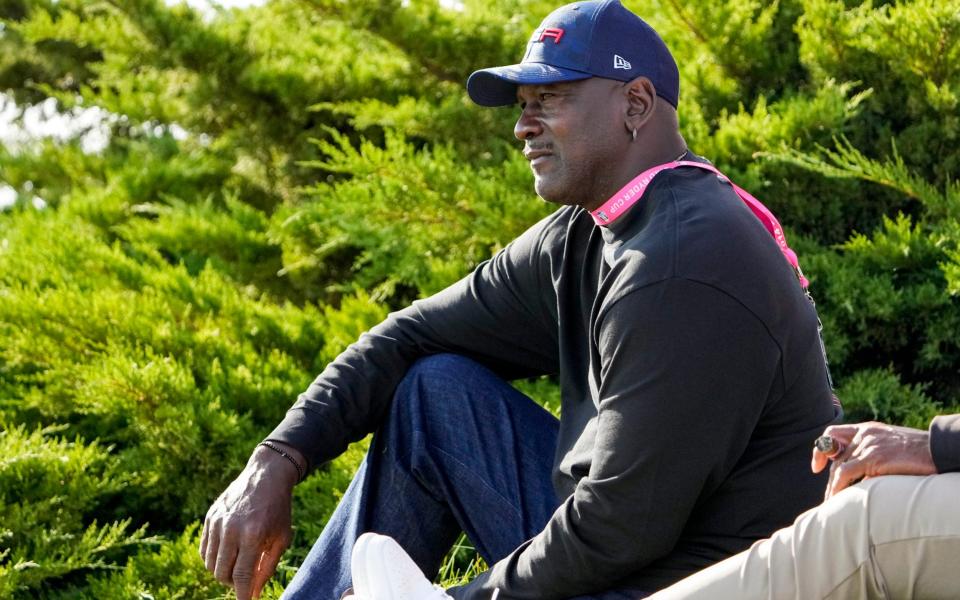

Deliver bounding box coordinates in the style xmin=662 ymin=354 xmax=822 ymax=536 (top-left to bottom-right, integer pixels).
xmin=590 ymin=160 xmax=810 ymax=290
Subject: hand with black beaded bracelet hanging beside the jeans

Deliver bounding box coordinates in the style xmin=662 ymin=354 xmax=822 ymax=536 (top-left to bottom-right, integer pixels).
xmin=200 ymin=442 xmax=305 ymax=600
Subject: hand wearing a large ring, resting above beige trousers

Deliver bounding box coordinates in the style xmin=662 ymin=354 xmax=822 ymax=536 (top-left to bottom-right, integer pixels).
xmin=810 ymin=422 xmax=937 ymax=500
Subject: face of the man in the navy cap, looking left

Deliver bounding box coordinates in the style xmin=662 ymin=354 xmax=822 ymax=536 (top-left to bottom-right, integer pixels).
xmin=514 ymin=77 xmax=630 ymax=209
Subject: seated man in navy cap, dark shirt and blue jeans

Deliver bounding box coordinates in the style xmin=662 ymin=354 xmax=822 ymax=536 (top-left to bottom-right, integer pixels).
xmin=201 ymin=0 xmax=835 ymax=600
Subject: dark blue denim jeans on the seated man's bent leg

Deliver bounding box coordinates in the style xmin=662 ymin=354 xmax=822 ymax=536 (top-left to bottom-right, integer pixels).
xmin=283 ymin=354 xmax=643 ymax=600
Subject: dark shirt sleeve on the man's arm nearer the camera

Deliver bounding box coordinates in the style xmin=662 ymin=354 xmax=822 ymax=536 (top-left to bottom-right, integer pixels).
xmin=450 ymin=279 xmax=782 ymax=600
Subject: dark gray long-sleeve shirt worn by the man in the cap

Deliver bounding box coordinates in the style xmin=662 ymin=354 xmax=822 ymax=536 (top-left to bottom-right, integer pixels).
xmin=270 ymin=157 xmax=835 ymax=600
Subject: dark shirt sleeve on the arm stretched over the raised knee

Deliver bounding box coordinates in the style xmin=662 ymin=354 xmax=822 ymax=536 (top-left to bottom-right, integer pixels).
xmin=267 ymin=213 xmax=559 ymax=468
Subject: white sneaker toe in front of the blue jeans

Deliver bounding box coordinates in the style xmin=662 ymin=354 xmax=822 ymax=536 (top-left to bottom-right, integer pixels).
xmin=350 ymin=533 xmax=453 ymax=600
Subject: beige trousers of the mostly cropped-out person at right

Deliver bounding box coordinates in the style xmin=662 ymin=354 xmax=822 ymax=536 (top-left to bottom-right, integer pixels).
xmin=650 ymin=473 xmax=960 ymax=600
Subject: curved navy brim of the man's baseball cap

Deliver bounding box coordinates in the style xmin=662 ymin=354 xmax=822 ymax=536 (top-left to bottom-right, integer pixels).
xmin=467 ymin=63 xmax=593 ymax=106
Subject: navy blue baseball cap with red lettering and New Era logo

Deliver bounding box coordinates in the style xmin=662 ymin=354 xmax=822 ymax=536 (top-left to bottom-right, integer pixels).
xmin=467 ymin=0 xmax=680 ymax=108
